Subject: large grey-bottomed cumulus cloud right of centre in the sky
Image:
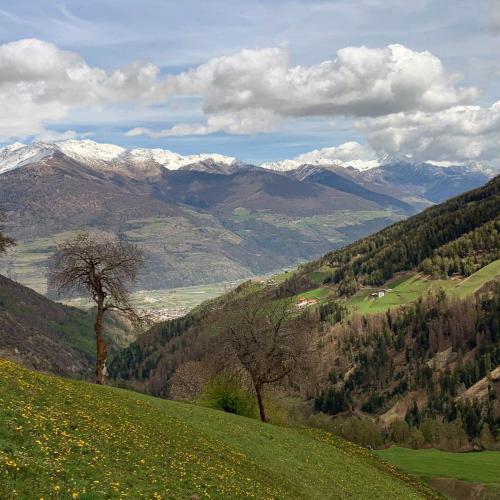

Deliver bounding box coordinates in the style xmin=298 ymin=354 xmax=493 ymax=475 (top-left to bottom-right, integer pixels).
xmin=133 ymin=45 xmax=477 ymax=136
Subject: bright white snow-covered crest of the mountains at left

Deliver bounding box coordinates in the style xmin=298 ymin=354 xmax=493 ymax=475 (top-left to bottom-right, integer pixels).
xmin=0 ymin=139 xmax=243 ymax=173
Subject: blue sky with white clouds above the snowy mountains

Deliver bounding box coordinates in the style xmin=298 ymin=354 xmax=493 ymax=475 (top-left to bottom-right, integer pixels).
xmin=0 ymin=0 xmax=500 ymax=166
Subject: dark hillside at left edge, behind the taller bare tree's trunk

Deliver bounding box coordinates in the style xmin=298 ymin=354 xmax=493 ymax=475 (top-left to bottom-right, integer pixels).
xmin=0 ymin=275 xmax=132 ymax=376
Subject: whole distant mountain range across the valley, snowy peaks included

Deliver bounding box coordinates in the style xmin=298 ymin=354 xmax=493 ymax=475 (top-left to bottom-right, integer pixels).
xmin=0 ymin=140 xmax=492 ymax=293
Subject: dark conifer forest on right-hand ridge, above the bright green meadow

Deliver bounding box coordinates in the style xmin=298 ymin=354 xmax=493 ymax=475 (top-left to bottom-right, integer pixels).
xmin=303 ymin=176 xmax=500 ymax=295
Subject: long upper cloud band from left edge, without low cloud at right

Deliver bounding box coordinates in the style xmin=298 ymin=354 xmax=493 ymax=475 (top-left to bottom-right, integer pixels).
xmin=0 ymin=39 xmax=477 ymax=137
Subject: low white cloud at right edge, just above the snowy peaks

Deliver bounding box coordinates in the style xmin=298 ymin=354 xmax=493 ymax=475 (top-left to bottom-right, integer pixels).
xmin=357 ymin=101 xmax=500 ymax=166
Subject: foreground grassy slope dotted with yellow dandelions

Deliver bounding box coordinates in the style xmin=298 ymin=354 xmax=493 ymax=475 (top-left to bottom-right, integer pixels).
xmin=0 ymin=359 xmax=434 ymax=499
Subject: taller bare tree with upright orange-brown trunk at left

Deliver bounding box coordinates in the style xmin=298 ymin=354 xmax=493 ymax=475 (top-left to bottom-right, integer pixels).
xmin=49 ymin=232 xmax=143 ymax=384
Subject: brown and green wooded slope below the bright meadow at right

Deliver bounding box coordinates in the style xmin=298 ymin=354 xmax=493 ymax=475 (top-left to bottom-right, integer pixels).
xmin=315 ymin=280 xmax=500 ymax=449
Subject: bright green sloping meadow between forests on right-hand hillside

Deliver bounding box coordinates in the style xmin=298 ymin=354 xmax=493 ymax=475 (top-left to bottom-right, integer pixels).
xmin=347 ymin=260 xmax=500 ymax=314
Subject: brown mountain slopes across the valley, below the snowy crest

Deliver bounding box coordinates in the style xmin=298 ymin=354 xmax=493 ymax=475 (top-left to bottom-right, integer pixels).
xmin=0 ymin=145 xmax=402 ymax=293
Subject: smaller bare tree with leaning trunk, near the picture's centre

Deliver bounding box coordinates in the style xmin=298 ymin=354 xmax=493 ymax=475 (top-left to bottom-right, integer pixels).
xmin=215 ymin=294 xmax=311 ymax=422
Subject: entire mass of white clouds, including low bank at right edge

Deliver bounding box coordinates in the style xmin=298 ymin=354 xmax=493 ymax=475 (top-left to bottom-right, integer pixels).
xmin=0 ymin=39 xmax=500 ymax=167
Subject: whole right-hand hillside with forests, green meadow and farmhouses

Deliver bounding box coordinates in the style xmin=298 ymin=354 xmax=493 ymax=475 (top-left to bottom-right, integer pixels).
xmin=110 ymin=178 xmax=500 ymax=449
